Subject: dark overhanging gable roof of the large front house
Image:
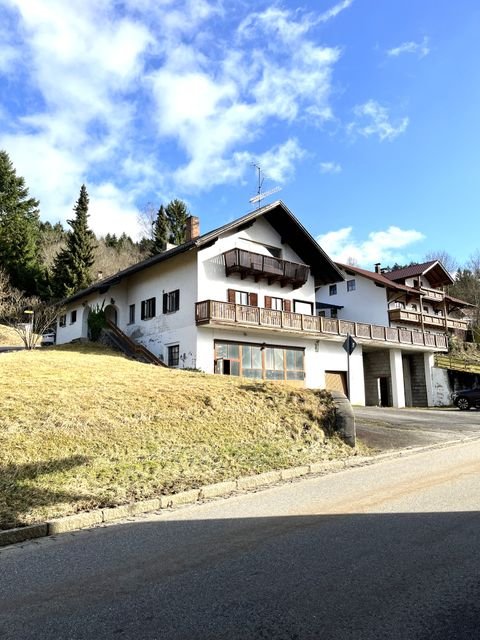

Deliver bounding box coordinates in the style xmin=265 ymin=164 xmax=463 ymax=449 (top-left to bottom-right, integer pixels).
xmin=65 ymin=200 xmax=343 ymax=302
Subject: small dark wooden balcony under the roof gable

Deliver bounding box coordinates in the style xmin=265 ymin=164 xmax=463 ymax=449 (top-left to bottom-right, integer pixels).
xmin=223 ymin=249 xmax=310 ymax=289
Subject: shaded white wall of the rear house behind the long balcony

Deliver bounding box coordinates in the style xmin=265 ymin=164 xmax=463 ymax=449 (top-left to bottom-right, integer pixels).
xmin=316 ymin=270 xmax=389 ymax=326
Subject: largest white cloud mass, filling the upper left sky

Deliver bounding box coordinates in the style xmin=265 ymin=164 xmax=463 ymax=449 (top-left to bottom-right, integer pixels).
xmin=0 ymin=0 xmax=353 ymax=233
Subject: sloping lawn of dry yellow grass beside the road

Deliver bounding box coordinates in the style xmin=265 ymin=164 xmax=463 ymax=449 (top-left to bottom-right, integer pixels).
xmin=0 ymin=345 xmax=360 ymax=528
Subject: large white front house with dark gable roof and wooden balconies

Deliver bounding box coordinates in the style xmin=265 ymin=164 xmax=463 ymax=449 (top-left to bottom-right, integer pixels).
xmin=57 ymin=201 xmax=454 ymax=406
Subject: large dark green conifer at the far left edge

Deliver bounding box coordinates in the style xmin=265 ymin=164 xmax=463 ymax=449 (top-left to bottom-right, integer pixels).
xmin=0 ymin=151 xmax=41 ymax=294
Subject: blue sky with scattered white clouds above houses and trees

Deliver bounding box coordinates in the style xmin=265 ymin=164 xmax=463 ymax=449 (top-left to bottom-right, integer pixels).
xmin=0 ymin=0 xmax=480 ymax=268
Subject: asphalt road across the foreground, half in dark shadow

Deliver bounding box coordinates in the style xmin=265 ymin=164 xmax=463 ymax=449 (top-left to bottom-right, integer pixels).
xmin=0 ymin=441 xmax=480 ymax=640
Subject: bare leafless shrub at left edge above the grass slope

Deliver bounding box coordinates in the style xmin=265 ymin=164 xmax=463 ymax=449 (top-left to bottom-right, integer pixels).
xmin=0 ymin=270 xmax=63 ymax=349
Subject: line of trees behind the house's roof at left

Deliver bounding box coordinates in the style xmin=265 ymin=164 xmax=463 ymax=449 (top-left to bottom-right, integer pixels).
xmin=0 ymin=150 xmax=189 ymax=301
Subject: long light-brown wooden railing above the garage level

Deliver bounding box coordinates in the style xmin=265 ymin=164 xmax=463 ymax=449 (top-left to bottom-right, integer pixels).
xmin=195 ymin=300 xmax=448 ymax=351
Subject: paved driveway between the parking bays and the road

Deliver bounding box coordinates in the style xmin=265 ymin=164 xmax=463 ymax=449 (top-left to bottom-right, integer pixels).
xmin=353 ymin=407 xmax=480 ymax=451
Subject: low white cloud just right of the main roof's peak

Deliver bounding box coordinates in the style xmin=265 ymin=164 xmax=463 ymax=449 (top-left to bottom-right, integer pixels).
xmin=317 ymin=226 xmax=425 ymax=270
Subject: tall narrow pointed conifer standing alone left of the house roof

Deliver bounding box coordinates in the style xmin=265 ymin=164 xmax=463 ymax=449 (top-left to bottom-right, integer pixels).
xmin=53 ymin=184 xmax=95 ymax=298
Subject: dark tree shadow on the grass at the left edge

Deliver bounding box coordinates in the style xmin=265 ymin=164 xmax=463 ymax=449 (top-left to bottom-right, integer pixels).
xmin=0 ymin=456 xmax=92 ymax=529
